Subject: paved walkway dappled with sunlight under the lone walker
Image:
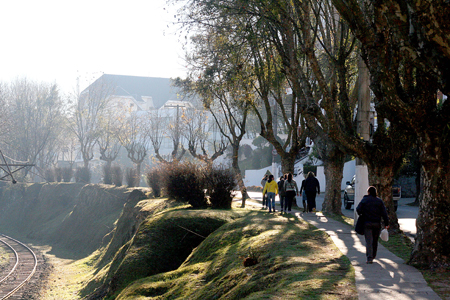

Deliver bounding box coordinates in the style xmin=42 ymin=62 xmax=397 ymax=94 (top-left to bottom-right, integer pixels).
xmin=241 ymin=193 xmax=441 ymax=300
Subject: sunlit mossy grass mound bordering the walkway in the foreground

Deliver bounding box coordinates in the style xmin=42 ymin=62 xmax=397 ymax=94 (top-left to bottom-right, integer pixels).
xmin=116 ymin=210 xmax=357 ymax=299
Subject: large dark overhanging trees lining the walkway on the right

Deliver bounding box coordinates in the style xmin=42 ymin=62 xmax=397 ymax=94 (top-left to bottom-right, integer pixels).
xmin=173 ymin=0 xmax=450 ymax=266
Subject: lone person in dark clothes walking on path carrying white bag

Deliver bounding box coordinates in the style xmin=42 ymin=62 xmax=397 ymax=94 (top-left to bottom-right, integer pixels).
xmin=356 ymin=186 xmax=389 ymax=264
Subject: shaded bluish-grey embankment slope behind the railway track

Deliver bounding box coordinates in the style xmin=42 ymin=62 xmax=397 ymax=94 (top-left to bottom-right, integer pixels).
xmin=0 ymin=183 xmax=144 ymax=258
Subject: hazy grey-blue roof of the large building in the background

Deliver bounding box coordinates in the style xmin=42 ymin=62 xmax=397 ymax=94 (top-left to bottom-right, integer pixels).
xmin=82 ymin=74 xmax=185 ymax=108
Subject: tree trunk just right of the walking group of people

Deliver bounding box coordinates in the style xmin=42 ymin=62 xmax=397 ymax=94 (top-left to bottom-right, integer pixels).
xmin=322 ymin=144 xmax=345 ymax=215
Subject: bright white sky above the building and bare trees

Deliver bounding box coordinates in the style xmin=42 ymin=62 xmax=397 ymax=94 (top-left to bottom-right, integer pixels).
xmin=0 ymin=0 xmax=186 ymax=92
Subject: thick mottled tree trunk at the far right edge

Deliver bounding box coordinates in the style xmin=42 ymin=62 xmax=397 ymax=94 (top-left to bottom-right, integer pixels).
xmin=411 ymin=132 xmax=450 ymax=268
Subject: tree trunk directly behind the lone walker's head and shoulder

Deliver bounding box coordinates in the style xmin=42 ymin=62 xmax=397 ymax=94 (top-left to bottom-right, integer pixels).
xmin=368 ymin=160 xmax=400 ymax=230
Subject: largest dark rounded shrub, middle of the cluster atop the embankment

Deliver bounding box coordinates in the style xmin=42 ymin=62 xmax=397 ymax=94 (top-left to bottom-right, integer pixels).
xmin=164 ymin=162 xmax=207 ymax=208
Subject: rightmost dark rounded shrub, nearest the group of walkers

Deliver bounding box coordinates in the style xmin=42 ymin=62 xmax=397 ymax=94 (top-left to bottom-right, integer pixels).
xmin=205 ymin=168 xmax=236 ymax=208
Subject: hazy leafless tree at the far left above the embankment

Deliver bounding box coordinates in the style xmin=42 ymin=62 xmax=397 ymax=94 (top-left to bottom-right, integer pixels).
xmin=2 ymin=78 xmax=64 ymax=177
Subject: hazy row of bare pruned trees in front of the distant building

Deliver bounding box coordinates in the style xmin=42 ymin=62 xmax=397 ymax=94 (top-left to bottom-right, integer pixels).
xmin=0 ymin=79 xmax=260 ymax=184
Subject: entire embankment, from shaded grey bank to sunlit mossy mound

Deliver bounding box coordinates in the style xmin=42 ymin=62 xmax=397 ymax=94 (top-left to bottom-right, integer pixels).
xmin=0 ymin=184 xmax=357 ymax=299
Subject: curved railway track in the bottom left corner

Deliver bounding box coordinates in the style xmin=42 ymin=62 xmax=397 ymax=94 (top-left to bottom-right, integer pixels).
xmin=0 ymin=234 xmax=37 ymax=300
